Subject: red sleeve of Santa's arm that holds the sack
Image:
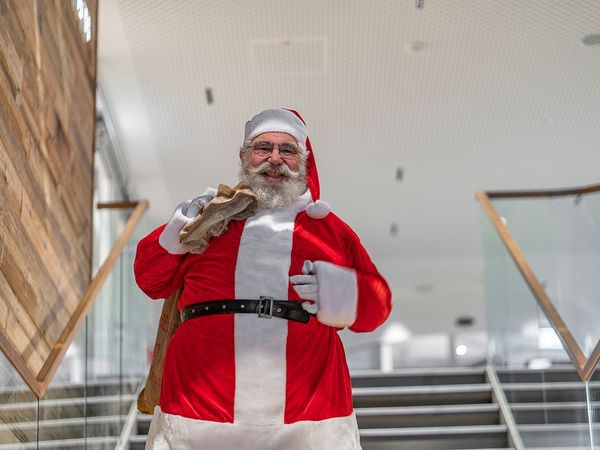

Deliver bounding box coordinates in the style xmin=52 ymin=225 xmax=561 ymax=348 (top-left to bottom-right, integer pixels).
xmin=133 ymin=225 xmax=186 ymax=299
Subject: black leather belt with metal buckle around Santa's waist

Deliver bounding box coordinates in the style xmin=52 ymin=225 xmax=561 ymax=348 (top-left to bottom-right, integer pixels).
xmin=180 ymin=297 xmax=311 ymax=323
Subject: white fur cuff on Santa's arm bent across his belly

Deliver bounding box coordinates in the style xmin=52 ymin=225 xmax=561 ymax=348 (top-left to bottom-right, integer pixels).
xmin=314 ymin=261 xmax=358 ymax=328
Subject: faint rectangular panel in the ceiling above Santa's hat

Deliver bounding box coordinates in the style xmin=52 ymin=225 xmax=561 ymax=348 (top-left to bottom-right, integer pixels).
xmin=250 ymin=37 xmax=327 ymax=76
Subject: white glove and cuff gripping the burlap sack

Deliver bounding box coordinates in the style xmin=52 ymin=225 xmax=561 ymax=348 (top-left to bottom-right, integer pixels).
xmin=158 ymin=189 xmax=216 ymax=255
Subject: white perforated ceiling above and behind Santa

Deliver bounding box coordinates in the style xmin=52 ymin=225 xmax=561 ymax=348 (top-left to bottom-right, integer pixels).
xmin=98 ymin=0 xmax=600 ymax=352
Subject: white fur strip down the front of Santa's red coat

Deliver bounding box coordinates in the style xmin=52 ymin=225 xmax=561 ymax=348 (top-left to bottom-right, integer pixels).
xmin=234 ymin=191 xmax=310 ymax=425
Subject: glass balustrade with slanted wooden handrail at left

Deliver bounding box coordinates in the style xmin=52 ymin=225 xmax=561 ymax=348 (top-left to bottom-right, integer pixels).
xmin=0 ymin=201 xmax=154 ymax=448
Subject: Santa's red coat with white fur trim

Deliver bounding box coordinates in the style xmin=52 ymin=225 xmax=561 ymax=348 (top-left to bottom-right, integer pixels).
xmin=134 ymin=191 xmax=391 ymax=449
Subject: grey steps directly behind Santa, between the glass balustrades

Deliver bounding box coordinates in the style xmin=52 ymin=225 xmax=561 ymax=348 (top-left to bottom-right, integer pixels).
xmin=130 ymin=368 xmax=509 ymax=450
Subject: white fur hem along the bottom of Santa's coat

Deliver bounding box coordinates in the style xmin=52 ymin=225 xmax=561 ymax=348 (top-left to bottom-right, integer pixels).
xmin=146 ymin=407 xmax=361 ymax=450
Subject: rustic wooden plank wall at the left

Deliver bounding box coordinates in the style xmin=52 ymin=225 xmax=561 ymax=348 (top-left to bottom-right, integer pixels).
xmin=0 ymin=0 xmax=97 ymax=394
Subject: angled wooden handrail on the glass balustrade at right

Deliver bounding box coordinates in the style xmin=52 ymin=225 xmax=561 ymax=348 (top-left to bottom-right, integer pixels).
xmin=476 ymin=185 xmax=600 ymax=381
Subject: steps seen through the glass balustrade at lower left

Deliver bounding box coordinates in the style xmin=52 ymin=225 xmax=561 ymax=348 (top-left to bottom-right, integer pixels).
xmin=0 ymin=380 xmax=139 ymax=450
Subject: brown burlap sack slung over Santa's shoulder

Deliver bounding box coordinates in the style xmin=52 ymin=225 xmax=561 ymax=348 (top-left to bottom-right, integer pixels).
xmin=137 ymin=183 xmax=258 ymax=414
